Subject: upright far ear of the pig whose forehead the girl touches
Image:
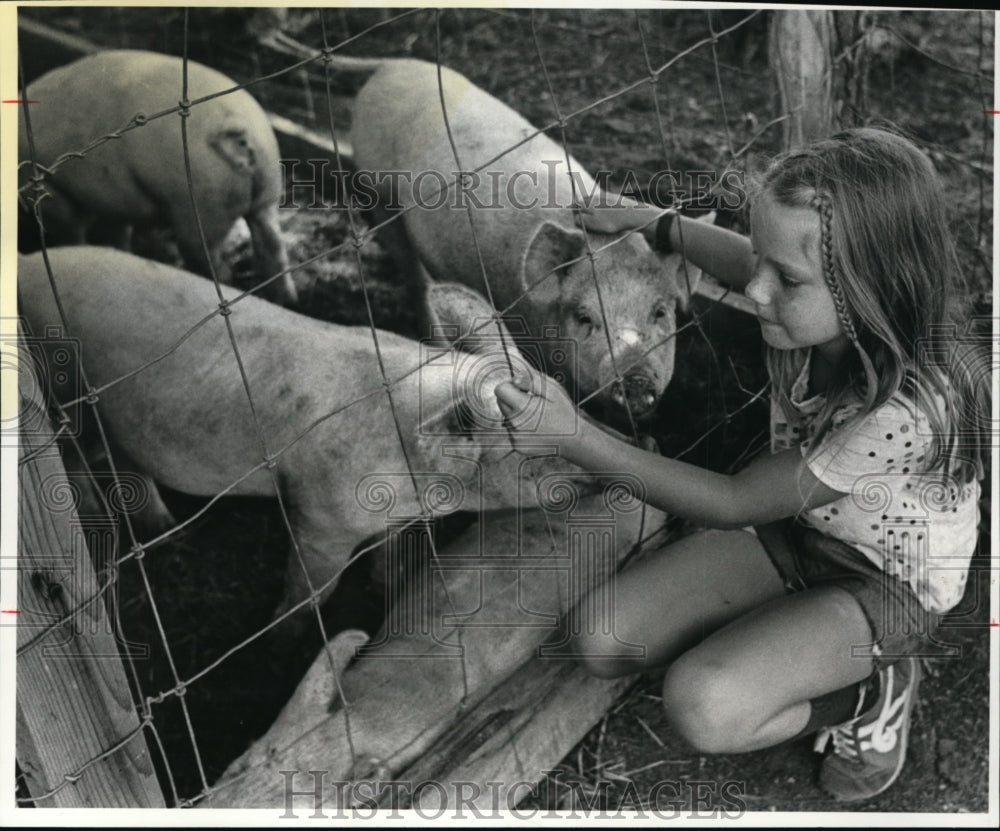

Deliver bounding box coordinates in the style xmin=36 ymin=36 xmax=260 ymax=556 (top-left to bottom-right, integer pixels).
xmin=426 ymin=282 xmax=517 ymax=360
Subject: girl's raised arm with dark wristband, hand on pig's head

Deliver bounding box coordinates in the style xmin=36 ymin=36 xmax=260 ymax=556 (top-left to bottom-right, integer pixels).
xmin=578 ymin=203 xmax=754 ymax=290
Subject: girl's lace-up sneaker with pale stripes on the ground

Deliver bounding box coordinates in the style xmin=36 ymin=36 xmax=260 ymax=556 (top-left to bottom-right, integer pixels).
xmin=814 ymin=658 xmax=920 ymax=802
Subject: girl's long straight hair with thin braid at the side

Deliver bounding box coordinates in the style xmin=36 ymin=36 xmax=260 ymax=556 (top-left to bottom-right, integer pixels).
xmin=755 ymin=128 xmax=989 ymax=482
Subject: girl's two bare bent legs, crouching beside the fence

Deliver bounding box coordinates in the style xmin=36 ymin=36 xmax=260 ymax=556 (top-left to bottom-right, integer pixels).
xmin=573 ymin=531 xmax=872 ymax=752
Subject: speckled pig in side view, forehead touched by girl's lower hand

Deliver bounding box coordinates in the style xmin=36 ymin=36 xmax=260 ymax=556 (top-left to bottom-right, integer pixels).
xmin=18 ymin=246 xmax=596 ymax=632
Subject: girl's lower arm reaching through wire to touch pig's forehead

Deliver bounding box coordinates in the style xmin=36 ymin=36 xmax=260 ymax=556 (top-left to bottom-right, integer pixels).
xmin=496 ymin=375 xmax=844 ymax=528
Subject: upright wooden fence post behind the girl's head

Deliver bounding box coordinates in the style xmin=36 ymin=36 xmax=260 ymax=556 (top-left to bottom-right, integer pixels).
xmin=768 ymin=10 xmax=833 ymax=150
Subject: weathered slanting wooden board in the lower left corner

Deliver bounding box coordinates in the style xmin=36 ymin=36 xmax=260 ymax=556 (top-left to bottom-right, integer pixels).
xmin=16 ymin=324 xmax=164 ymax=808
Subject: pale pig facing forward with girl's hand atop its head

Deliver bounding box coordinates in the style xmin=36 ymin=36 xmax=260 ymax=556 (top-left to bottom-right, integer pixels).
xmin=348 ymin=59 xmax=701 ymax=422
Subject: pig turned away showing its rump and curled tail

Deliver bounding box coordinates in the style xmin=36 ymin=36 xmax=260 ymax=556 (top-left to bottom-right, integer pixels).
xmin=18 ymin=49 xmax=297 ymax=305
